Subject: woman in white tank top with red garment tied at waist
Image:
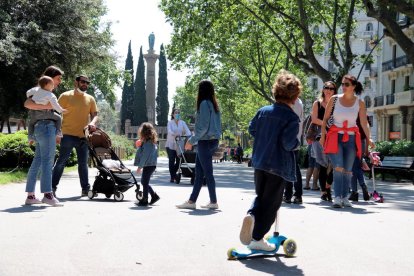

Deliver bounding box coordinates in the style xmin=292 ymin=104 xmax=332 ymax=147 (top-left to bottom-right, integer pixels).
xmin=320 ymin=75 xmax=374 ymax=208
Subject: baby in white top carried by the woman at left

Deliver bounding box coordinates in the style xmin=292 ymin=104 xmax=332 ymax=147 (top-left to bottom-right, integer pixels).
xmin=26 ymin=76 xmax=67 ymax=144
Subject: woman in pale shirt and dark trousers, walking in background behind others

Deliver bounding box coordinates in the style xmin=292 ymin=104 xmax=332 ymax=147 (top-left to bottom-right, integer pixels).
xmin=165 ymin=108 xmax=191 ymax=182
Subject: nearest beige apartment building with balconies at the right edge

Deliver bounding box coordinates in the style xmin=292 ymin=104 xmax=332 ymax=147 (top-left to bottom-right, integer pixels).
xmin=368 ymin=14 xmax=414 ymax=141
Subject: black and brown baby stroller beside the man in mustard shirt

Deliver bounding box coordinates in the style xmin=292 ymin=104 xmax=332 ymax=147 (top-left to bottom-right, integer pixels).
xmin=84 ymin=128 xmax=142 ymax=201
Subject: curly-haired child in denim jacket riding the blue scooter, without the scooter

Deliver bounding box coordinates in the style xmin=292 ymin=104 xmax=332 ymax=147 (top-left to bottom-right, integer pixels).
xmin=240 ymin=70 xmax=302 ymax=251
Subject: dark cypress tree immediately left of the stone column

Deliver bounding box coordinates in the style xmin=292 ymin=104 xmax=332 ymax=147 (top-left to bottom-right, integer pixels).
xmin=133 ymin=46 xmax=148 ymax=126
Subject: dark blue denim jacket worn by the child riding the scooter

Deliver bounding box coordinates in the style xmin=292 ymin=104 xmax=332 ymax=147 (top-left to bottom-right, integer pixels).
xmin=249 ymin=103 xmax=300 ymax=182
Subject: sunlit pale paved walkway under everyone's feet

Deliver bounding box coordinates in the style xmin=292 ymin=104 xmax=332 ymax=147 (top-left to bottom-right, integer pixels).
xmin=0 ymin=158 xmax=414 ymax=276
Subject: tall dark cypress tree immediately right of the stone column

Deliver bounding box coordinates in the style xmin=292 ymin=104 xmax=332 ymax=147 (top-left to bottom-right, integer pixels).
xmin=156 ymin=44 xmax=170 ymax=126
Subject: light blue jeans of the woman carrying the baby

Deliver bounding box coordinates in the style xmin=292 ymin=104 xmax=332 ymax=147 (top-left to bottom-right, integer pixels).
xmin=26 ymin=120 xmax=56 ymax=193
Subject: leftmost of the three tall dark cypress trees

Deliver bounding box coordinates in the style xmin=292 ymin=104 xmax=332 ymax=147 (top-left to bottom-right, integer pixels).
xmin=121 ymin=41 xmax=135 ymax=134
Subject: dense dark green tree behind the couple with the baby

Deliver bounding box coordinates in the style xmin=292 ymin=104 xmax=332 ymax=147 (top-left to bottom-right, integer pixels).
xmin=0 ymin=0 xmax=122 ymax=122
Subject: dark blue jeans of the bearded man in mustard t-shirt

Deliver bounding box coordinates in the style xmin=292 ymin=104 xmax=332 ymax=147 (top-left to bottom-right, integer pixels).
xmin=52 ymin=135 xmax=90 ymax=190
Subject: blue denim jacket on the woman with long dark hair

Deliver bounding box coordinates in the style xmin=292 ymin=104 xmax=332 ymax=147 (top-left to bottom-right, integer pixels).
xmin=188 ymin=100 xmax=221 ymax=145
